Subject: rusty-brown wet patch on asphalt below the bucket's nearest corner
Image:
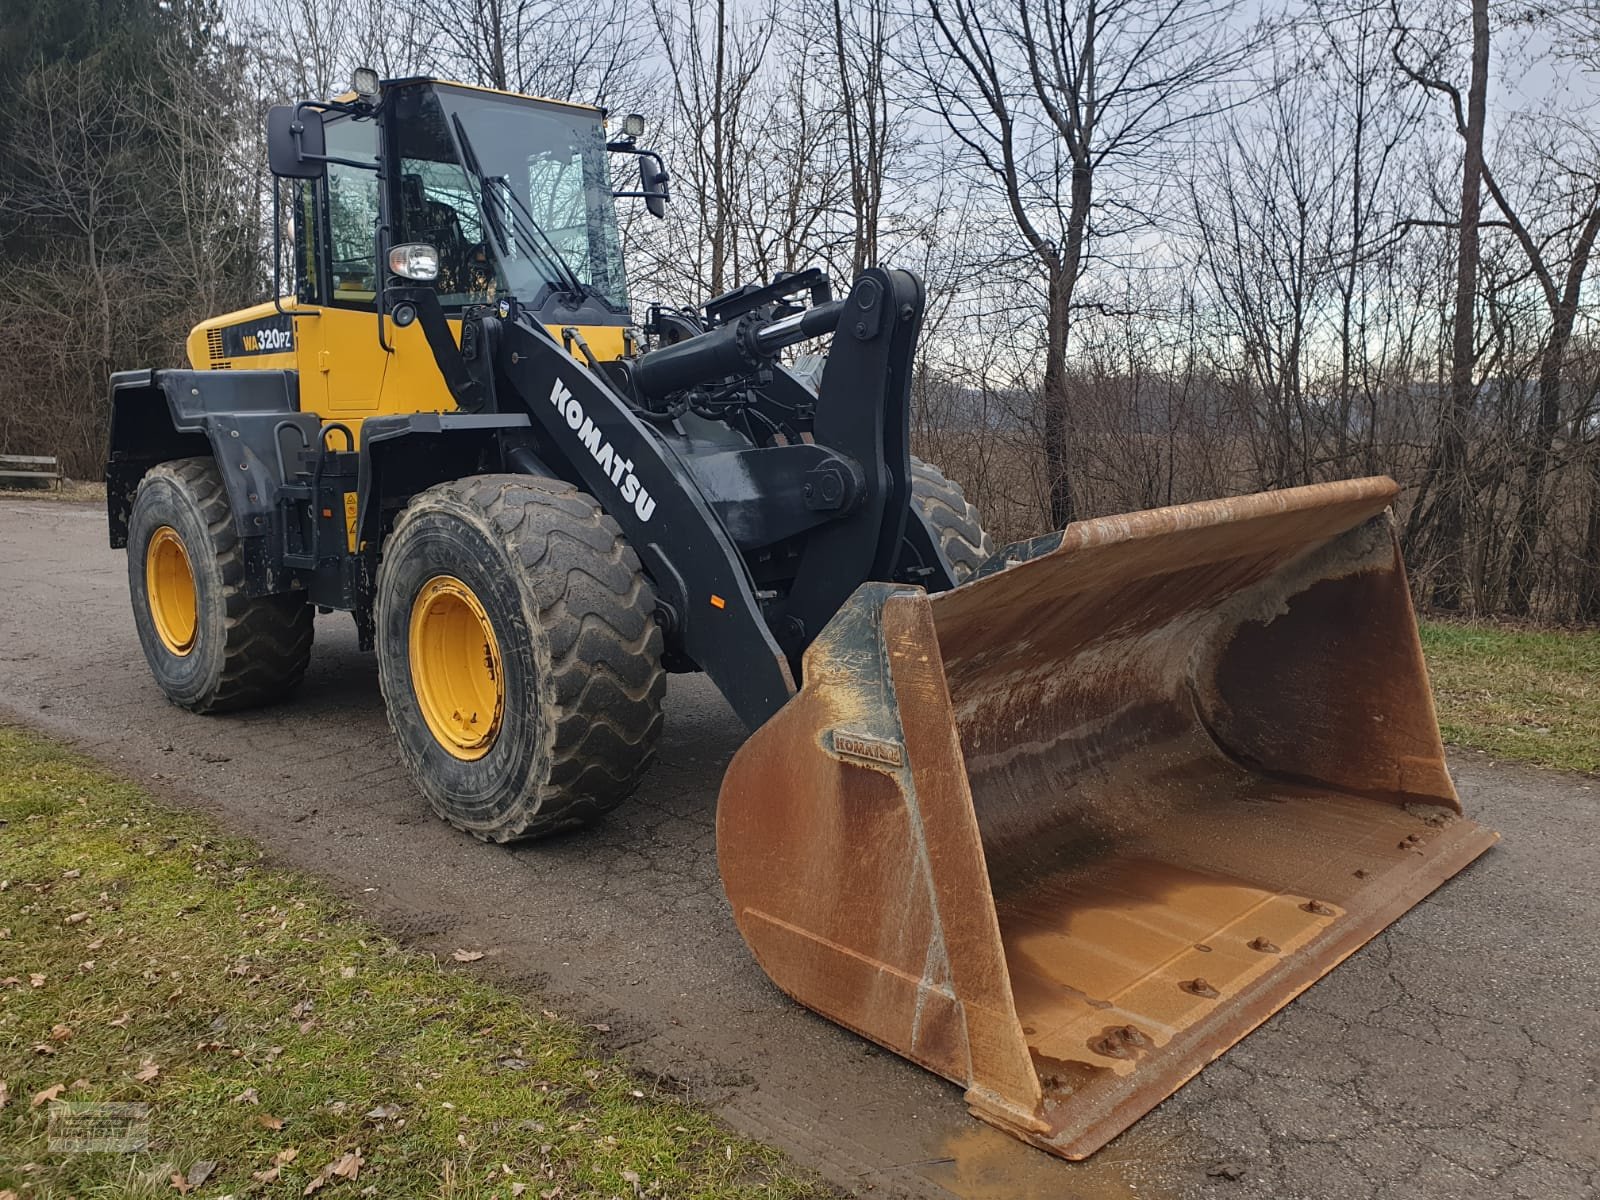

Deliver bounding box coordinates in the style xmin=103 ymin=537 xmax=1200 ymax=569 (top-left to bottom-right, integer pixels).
xmin=923 ymin=1122 xmax=1178 ymax=1200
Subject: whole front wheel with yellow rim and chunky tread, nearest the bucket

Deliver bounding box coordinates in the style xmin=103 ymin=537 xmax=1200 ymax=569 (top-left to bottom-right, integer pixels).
xmin=374 ymin=475 xmax=666 ymax=842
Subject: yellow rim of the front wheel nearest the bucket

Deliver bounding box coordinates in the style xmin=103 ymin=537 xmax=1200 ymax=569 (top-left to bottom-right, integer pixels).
xmin=411 ymin=574 xmax=506 ymax=762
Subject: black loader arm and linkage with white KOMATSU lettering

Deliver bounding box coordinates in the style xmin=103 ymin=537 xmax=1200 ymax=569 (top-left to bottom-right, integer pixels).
xmin=406 ymin=269 xmax=934 ymax=728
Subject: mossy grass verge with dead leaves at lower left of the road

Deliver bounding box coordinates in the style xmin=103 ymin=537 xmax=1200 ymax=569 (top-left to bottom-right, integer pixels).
xmin=0 ymin=726 xmax=827 ymax=1200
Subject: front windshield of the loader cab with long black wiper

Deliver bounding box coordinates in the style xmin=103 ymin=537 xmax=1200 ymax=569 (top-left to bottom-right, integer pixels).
xmin=394 ymin=86 xmax=629 ymax=312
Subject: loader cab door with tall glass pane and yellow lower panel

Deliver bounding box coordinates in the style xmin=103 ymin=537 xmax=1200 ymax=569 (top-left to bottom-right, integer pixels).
xmin=298 ymin=117 xmax=389 ymax=422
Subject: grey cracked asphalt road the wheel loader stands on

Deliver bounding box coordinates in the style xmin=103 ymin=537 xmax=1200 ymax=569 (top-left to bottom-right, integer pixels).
xmin=0 ymin=499 xmax=1600 ymax=1200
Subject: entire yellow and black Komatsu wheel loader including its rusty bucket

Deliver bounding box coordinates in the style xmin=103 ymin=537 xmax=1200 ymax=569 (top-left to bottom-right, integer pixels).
xmin=106 ymin=70 xmax=1496 ymax=1158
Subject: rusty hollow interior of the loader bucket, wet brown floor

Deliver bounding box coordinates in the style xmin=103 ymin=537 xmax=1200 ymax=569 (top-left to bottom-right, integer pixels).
xmin=933 ymin=489 xmax=1478 ymax=1110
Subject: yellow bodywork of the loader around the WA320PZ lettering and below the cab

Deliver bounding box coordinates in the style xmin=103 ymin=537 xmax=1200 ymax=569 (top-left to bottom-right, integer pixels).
xmin=186 ymin=296 xmax=627 ymax=438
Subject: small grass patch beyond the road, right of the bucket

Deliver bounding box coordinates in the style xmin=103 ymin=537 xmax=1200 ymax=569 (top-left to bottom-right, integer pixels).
xmin=1422 ymin=621 xmax=1600 ymax=773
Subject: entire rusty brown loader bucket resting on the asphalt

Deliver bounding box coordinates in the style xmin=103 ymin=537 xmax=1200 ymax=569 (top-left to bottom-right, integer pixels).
xmin=717 ymin=478 xmax=1496 ymax=1158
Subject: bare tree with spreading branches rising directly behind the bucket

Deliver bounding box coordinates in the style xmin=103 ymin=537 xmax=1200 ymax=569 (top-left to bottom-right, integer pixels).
xmin=915 ymin=0 xmax=1256 ymax=525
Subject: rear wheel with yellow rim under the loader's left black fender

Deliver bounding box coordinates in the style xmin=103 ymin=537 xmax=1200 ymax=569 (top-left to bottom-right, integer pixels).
xmin=128 ymin=458 xmax=314 ymax=712
